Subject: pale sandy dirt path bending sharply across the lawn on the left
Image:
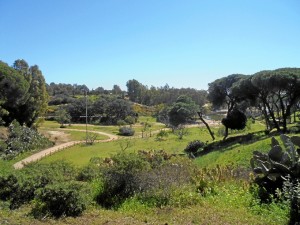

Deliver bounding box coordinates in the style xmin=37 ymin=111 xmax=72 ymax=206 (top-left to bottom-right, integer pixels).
xmin=13 ymin=129 xmax=119 ymax=169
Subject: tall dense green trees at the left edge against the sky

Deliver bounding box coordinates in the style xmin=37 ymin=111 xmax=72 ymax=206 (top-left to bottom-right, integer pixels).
xmin=0 ymin=60 xmax=48 ymax=126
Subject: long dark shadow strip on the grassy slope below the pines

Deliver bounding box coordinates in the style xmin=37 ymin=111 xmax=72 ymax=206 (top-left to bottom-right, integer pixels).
xmin=195 ymin=131 xmax=275 ymax=157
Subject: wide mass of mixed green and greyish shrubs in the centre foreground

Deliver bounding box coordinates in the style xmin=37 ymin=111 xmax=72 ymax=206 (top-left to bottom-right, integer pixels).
xmin=96 ymin=152 xmax=196 ymax=208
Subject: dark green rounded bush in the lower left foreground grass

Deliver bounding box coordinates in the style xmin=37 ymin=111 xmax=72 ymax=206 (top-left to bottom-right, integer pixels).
xmin=32 ymin=182 xmax=86 ymax=218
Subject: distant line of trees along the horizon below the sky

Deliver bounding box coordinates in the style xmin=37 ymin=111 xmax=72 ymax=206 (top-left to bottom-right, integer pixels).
xmin=47 ymin=79 xmax=207 ymax=106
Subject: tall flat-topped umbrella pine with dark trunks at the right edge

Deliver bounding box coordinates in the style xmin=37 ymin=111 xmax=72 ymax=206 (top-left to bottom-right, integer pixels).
xmin=252 ymin=68 xmax=300 ymax=132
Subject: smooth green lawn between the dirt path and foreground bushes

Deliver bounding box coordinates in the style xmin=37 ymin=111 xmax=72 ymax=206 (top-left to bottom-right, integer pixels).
xmin=40 ymin=127 xmax=218 ymax=166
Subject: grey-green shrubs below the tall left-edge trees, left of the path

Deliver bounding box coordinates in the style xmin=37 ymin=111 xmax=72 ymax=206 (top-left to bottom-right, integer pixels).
xmin=1 ymin=121 xmax=53 ymax=159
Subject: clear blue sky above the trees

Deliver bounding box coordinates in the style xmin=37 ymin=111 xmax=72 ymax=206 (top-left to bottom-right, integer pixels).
xmin=0 ymin=0 xmax=300 ymax=90
